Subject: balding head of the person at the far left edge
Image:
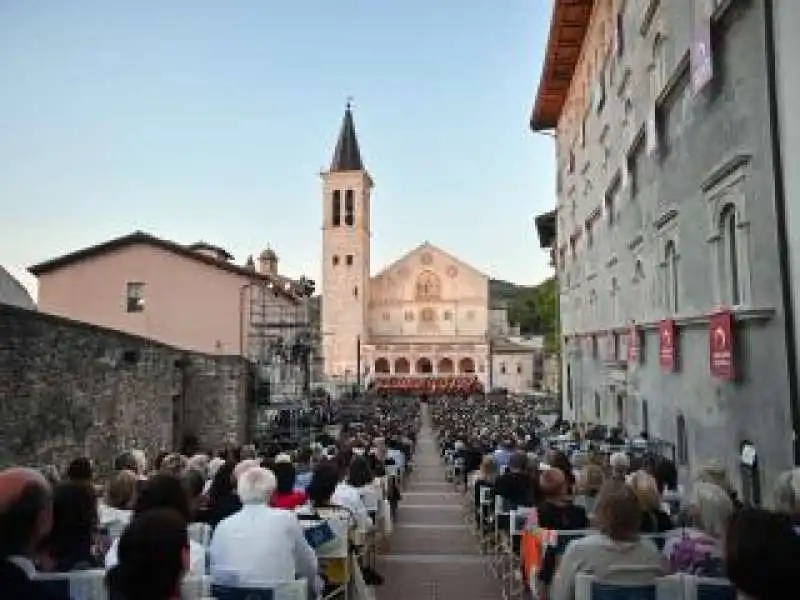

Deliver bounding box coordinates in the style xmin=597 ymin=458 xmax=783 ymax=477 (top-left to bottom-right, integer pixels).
xmin=0 ymin=467 xmax=53 ymax=560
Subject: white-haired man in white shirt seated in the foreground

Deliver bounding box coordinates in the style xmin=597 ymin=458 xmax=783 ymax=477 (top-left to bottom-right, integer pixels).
xmin=210 ymin=467 xmax=321 ymax=598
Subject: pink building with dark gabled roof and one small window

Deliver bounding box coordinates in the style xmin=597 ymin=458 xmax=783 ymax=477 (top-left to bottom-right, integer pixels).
xmin=28 ymin=231 xmax=300 ymax=355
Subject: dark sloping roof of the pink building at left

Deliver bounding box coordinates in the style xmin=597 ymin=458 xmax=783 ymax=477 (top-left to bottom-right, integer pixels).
xmin=28 ymin=231 xmax=298 ymax=301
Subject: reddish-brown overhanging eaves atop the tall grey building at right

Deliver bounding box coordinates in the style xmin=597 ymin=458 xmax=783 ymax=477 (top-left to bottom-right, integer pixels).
xmin=531 ymin=0 xmax=594 ymax=131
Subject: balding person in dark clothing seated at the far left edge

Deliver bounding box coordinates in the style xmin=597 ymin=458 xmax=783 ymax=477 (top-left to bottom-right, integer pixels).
xmin=0 ymin=467 xmax=67 ymax=600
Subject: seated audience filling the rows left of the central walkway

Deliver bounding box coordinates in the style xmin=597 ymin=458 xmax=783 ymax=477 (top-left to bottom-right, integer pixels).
xmin=0 ymin=398 xmax=419 ymax=600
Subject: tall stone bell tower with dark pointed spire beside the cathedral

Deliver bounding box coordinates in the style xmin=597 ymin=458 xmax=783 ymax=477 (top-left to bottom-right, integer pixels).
xmin=321 ymin=102 xmax=373 ymax=383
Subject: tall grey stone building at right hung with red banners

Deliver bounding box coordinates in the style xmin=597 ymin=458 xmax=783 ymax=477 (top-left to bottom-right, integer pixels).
xmin=531 ymin=0 xmax=794 ymax=489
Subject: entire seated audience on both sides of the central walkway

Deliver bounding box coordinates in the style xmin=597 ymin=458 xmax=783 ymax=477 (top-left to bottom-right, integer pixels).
xmin=0 ymin=394 xmax=800 ymax=600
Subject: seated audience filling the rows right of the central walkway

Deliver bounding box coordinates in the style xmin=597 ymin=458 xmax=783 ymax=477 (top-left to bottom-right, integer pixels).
xmin=433 ymin=398 xmax=800 ymax=600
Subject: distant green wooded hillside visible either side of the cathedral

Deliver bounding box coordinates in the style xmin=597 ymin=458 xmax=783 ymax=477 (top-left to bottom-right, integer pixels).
xmin=309 ymin=277 xmax=558 ymax=341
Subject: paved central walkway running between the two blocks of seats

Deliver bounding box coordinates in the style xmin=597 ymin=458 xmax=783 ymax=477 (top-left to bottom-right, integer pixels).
xmin=377 ymin=406 xmax=501 ymax=600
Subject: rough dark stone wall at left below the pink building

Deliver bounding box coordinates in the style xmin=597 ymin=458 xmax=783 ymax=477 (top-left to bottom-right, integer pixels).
xmin=0 ymin=305 xmax=249 ymax=469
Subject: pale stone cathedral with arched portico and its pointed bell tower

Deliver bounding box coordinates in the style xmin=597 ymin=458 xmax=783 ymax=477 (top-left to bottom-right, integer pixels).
xmin=322 ymin=106 xmax=489 ymax=384
